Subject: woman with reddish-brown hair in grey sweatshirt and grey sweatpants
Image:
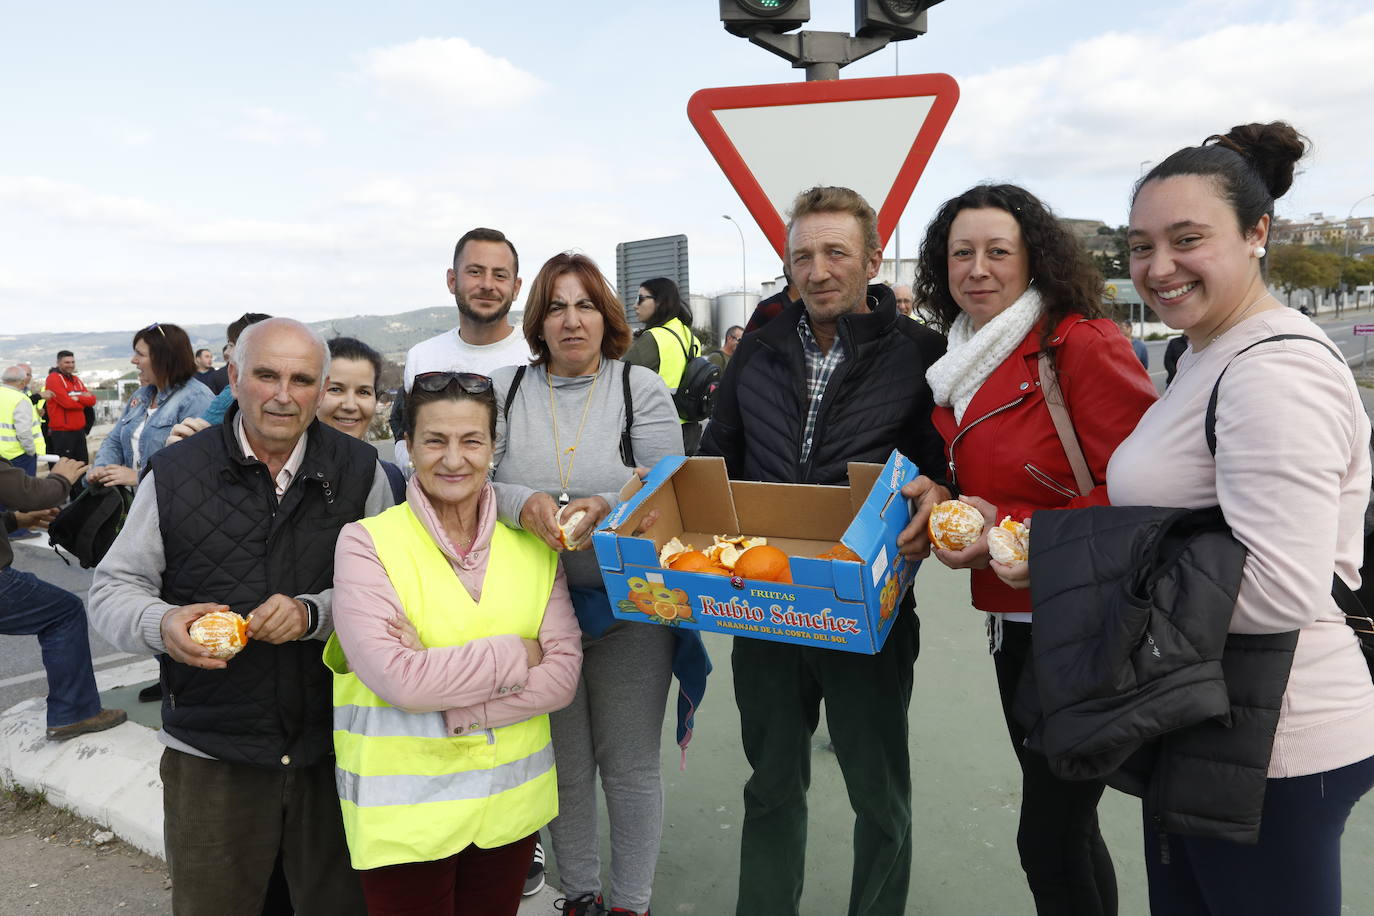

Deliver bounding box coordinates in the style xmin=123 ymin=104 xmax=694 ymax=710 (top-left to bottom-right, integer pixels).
xmin=493 ymin=254 xmax=706 ymax=916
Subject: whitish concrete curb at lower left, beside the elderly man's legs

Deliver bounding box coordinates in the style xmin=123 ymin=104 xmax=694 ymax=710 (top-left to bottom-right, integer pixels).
xmin=0 ymin=659 xmax=165 ymax=858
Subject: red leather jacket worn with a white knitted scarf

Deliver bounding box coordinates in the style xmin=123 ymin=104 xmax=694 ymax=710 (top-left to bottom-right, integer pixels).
xmin=932 ymin=316 xmax=1158 ymax=611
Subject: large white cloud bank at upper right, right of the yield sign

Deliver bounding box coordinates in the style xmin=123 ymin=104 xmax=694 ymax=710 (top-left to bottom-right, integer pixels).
xmin=941 ymin=14 xmax=1374 ymax=193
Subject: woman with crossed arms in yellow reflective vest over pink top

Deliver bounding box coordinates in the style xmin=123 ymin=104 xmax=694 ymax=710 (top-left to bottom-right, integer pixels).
xmin=324 ymin=372 xmax=583 ymax=916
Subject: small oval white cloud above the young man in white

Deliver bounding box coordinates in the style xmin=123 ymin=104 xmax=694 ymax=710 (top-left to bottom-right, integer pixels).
xmin=363 ymin=38 xmax=543 ymax=114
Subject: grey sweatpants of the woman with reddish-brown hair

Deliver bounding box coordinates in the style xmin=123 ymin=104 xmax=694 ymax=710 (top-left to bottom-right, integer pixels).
xmin=548 ymin=621 xmax=673 ymax=913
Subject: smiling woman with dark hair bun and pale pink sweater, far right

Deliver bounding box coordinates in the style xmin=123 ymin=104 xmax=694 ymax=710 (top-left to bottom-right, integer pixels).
xmin=999 ymin=122 xmax=1374 ymax=916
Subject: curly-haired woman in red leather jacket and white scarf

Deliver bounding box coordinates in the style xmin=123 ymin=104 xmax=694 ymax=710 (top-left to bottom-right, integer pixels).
xmin=904 ymin=184 xmax=1156 ymax=916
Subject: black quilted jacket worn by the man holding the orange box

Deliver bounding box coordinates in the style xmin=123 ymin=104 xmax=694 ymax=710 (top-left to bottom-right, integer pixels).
xmin=699 ymin=286 xmax=945 ymax=485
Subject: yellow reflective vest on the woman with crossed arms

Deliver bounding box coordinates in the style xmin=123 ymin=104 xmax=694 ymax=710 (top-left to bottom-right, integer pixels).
xmin=324 ymin=503 xmax=558 ymax=868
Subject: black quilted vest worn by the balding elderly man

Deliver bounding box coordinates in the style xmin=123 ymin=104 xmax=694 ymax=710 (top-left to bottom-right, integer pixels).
xmin=153 ymin=405 xmax=376 ymax=768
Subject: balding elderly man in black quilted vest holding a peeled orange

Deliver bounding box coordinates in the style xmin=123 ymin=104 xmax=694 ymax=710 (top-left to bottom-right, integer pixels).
xmin=89 ymin=319 xmax=392 ymax=916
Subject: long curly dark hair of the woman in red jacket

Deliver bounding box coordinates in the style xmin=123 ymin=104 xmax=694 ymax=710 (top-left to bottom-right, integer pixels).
xmin=915 ymin=184 xmax=1106 ymax=360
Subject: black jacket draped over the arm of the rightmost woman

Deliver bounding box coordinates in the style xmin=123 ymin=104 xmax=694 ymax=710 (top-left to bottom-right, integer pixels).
xmin=1033 ymin=505 xmax=1297 ymax=843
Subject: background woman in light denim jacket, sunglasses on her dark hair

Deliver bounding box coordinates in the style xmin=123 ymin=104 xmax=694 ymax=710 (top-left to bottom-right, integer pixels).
xmin=87 ymin=324 xmax=214 ymax=486
